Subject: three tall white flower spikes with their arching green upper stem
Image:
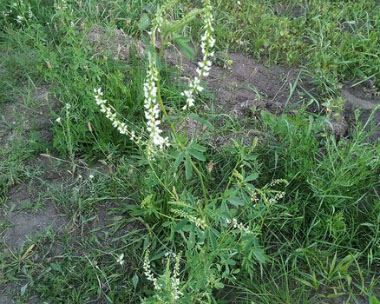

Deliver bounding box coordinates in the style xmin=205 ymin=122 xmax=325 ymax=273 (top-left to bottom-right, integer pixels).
xmin=94 ymin=0 xmax=215 ymax=156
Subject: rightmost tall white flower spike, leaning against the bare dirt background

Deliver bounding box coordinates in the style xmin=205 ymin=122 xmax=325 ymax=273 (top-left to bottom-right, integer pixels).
xmin=181 ymin=0 xmax=215 ymax=110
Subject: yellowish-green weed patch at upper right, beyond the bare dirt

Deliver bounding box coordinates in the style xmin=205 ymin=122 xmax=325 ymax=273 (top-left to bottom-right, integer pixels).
xmin=212 ymin=0 xmax=380 ymax=95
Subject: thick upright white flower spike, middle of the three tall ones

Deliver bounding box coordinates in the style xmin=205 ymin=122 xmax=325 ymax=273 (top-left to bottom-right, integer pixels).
xmin=144 ymin=53 xmax=169 ymax=149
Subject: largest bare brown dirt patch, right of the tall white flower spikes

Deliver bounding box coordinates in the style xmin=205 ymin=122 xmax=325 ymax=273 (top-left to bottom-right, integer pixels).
xmin=208 ymin=53 xmax=314 ymax=117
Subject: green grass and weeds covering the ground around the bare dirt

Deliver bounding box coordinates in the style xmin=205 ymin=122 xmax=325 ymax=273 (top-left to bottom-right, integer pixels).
xmin=0 ymin=0 xmax=380 ymax=304
